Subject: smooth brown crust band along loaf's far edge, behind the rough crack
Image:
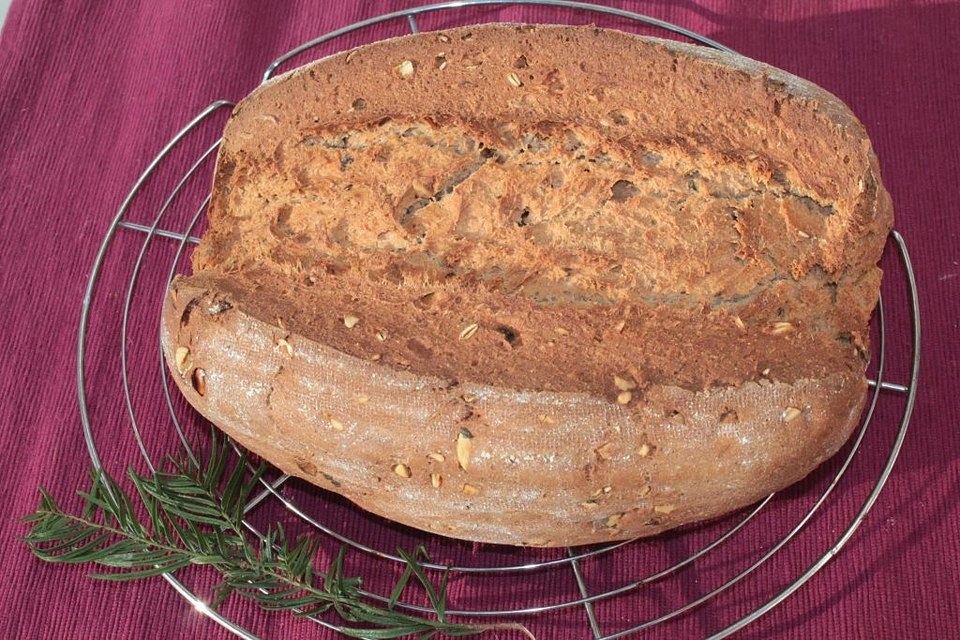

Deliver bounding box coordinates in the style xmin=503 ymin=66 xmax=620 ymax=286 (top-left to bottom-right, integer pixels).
xmin=209 ymin=24 xmax=892 ymax=268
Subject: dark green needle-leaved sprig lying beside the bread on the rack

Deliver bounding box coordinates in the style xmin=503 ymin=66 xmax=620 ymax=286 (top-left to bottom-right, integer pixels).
xmin=24 ymin=433 xmax=534 ymax=640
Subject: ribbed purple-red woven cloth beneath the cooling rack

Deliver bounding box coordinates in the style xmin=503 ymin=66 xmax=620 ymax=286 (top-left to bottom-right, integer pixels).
xmin=0 ymin=0 xmax=960 ymax=639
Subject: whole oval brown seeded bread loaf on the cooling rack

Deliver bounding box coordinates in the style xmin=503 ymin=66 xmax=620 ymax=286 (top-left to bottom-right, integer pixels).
xmin=162 ymin=25 xmax=892 ymax=546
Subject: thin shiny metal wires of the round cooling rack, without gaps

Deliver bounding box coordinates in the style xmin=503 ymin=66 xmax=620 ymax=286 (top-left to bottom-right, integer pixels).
xmin=76 ymin=0 xmax=920 ymax=640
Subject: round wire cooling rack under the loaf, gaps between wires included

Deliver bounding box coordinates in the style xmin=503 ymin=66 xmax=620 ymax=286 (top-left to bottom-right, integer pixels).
xmin=77 ymin=0 xmax=920 ymax=640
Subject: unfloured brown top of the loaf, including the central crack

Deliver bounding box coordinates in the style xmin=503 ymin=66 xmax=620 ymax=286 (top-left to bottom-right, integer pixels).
xmin=193 ymin=25 xmax=892 ymax=403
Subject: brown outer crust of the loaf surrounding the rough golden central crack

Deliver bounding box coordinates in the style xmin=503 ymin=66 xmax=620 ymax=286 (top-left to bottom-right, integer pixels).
xmin=163 ymin=25 xmax=892 ymax=545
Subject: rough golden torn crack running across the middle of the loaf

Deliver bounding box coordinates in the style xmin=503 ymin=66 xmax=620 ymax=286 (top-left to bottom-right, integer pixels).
xmin=199 ymin=119 xmax=856 ymax=305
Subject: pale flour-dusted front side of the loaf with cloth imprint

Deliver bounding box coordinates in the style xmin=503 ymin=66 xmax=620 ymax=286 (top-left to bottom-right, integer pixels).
xmin=163 ymin=276 xmax=865 ymax=546
